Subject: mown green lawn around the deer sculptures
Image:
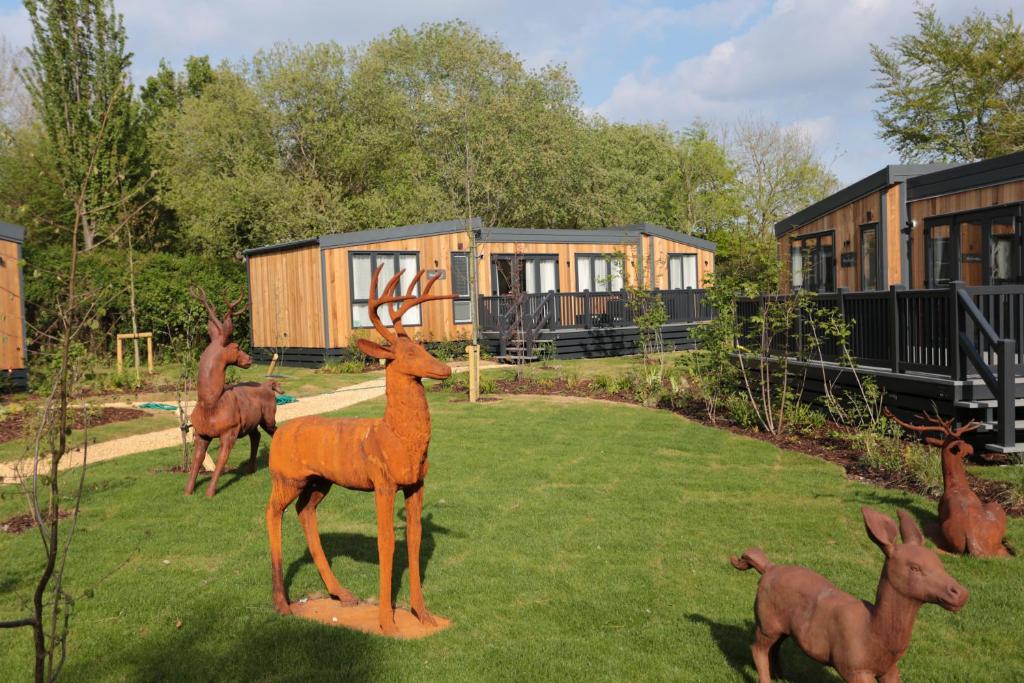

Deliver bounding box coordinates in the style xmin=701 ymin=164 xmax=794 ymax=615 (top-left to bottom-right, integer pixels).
xmin=0 ymin=394 xmax=1024 ymax=681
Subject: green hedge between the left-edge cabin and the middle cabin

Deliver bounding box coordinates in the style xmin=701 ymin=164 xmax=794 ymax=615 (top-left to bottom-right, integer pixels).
xmin=25 ymin=247 xmax=249 ymax=352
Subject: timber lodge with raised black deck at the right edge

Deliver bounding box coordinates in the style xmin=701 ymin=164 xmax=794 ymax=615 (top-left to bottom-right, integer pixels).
xmin=765 ymin=153 xmax=1024 ymax=453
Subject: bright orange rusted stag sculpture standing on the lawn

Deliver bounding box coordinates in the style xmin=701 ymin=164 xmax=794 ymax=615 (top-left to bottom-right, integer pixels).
xmin=266 ymin=267 xmax=453 ymax=635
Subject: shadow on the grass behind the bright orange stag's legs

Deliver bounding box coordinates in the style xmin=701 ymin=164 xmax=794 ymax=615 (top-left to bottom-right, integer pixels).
xmin=285 ymin=509 xmax=452 ymax=599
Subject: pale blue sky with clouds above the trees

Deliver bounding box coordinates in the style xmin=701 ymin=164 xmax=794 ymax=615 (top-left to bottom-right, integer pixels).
xmin=0 ymin=0 xmax=1003 ymax=184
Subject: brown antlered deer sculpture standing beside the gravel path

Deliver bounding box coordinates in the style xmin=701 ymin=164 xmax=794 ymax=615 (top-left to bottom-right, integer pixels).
xmin=185 ymin=287 xmax=281 ymax=498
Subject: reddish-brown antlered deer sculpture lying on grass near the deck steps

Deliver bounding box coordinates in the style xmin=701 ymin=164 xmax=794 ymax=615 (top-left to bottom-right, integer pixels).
xmin=886 ymin=412 xmax=1010 ymax=557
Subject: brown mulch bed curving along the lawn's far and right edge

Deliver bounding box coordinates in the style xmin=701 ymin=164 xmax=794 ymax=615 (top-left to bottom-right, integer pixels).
xmin=458 ymin=378 xmax=1024 ymax=517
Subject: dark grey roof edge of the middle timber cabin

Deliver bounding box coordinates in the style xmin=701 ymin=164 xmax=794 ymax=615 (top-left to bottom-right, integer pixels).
xmin=243 ymin=218 xmax=715 ymax=256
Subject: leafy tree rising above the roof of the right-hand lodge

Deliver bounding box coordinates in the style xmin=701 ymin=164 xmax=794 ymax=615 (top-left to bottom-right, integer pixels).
xmin=871 ymin=6 xmax=1024 ymax=161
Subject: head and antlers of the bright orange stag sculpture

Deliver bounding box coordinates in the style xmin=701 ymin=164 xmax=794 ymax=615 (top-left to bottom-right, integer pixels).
xmin=356 ymin=264 xmax=455 ymax=380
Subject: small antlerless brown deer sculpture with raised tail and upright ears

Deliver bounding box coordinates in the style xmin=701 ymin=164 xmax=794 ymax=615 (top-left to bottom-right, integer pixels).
xmin=730 ymin=507 xmax=968 ymax=683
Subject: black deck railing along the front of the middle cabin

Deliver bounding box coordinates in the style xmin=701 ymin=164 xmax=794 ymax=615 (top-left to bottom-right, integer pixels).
xmin=479 ymin=290 xmax=714 ymax=332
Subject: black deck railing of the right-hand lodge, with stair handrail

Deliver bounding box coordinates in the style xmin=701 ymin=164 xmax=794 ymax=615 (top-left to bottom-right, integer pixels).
xmin=736 ymin=283 xmax=1024 ymax=445
